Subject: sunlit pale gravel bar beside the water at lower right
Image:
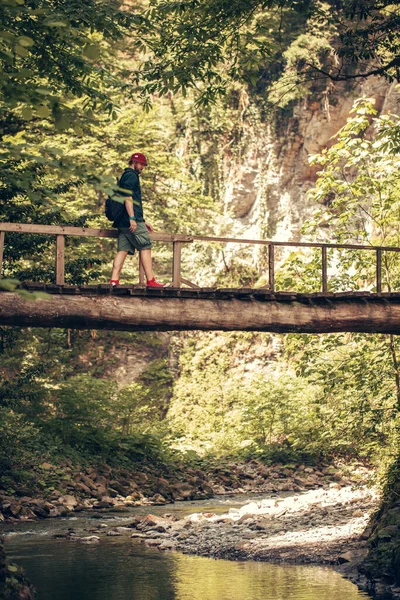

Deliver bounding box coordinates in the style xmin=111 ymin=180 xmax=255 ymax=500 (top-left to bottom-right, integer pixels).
xmin=115 ymin=484 xmax=378 ymax=566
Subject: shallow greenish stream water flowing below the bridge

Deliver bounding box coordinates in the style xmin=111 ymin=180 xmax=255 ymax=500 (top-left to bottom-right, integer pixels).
xmin=2 ymin=498 xmax=370 ymax=600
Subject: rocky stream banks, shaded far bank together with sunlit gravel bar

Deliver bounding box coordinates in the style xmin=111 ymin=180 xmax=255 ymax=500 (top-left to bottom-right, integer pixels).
xmin=0 ymin=460 xmax=379 ymax=591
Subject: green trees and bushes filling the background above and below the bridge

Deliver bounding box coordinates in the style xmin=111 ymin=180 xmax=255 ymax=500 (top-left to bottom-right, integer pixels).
xmin=0 ymin=0 xmax=400 ymax=500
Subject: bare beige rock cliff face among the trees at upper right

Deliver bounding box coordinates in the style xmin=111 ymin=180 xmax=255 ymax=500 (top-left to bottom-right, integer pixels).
xmin=221 ymin=78 xmax=400 ymax=248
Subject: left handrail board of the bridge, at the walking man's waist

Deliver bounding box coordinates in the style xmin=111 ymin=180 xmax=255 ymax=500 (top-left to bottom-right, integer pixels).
xmin=0 ymin=223 xmax=193 ymax=242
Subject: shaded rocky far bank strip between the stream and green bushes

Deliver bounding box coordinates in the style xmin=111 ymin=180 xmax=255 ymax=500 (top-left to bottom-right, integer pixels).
xmin=0 ymin=460 xmax=369 ymax=521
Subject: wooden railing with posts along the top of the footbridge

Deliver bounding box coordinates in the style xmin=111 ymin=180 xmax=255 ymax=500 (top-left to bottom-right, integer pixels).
xmin=0 ymin=223 xmax=400 ymax=294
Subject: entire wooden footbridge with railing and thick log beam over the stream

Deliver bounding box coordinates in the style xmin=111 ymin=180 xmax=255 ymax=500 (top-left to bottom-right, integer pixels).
xmin=0 ymin=223 xmax=400 ymax=334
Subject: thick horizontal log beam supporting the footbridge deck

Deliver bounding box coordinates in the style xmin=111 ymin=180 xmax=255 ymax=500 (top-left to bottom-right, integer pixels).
xmin=0 ymin=292 xmax=400 ymax=334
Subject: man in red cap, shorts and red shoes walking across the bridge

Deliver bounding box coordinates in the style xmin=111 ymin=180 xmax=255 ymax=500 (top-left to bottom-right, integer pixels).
xmin=110 ymin=152 xmax=165 ymax=288
